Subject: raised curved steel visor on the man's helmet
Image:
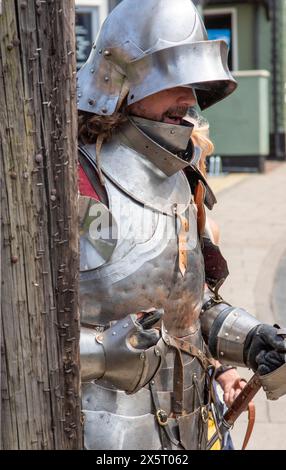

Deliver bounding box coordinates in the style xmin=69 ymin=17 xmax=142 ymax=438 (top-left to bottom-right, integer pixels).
xmin=126 ymin=41 xmax=237 ymax=109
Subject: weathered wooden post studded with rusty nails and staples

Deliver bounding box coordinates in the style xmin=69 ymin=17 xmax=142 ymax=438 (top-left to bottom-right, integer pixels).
xmin=0 ymin=0 xmax=82 ymax=449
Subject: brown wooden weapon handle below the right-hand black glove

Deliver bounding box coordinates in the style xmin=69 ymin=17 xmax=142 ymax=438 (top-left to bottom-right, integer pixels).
xmin=223 ymin=374 xmax=261 ymax=426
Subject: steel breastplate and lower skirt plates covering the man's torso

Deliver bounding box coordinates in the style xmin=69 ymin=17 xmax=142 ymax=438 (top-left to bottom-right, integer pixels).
xmin=80 ymin=126 xmax=210 ymax=450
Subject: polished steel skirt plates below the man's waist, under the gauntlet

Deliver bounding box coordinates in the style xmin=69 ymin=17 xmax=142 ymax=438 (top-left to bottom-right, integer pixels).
xmin=82 ymin=324 xmax=206 ymax=450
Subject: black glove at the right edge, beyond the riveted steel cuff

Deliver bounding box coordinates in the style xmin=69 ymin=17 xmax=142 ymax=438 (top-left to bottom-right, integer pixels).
xmin=243 ymin=324 xmax=286 ymax=375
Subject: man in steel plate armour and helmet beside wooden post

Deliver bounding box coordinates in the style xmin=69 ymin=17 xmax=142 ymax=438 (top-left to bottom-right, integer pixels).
xmin=78 ymin=0 xmax=286 ymax=450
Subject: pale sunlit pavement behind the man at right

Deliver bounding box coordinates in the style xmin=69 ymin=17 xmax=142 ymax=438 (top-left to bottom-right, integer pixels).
xmin=209 ymin=163 xmax=286 ymax=450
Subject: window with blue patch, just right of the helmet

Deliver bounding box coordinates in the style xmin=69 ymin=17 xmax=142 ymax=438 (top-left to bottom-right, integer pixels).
xmin=204 ymin=8 xmax=238 ymax=70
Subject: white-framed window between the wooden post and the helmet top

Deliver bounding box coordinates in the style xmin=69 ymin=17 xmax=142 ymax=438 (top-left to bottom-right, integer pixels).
xmin=75 ymin=0 xmax=108 ymax=68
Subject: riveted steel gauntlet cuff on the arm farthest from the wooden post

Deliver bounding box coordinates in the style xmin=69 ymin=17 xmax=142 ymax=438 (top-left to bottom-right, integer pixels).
xmin=201 ymin=291 xmax=260 ymax=366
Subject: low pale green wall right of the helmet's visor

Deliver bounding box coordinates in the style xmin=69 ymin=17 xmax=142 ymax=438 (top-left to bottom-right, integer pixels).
xmin=203 ymin=71 xmax=269 ymax=156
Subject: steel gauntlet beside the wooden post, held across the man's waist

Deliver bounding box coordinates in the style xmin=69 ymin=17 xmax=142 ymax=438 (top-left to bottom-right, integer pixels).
xmin=81 ymin=314 xmax=167 ymax=393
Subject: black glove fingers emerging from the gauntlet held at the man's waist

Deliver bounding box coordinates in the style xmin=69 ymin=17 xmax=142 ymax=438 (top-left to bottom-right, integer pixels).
xmin=129 ymin=309 xmax=164 ymax=349
